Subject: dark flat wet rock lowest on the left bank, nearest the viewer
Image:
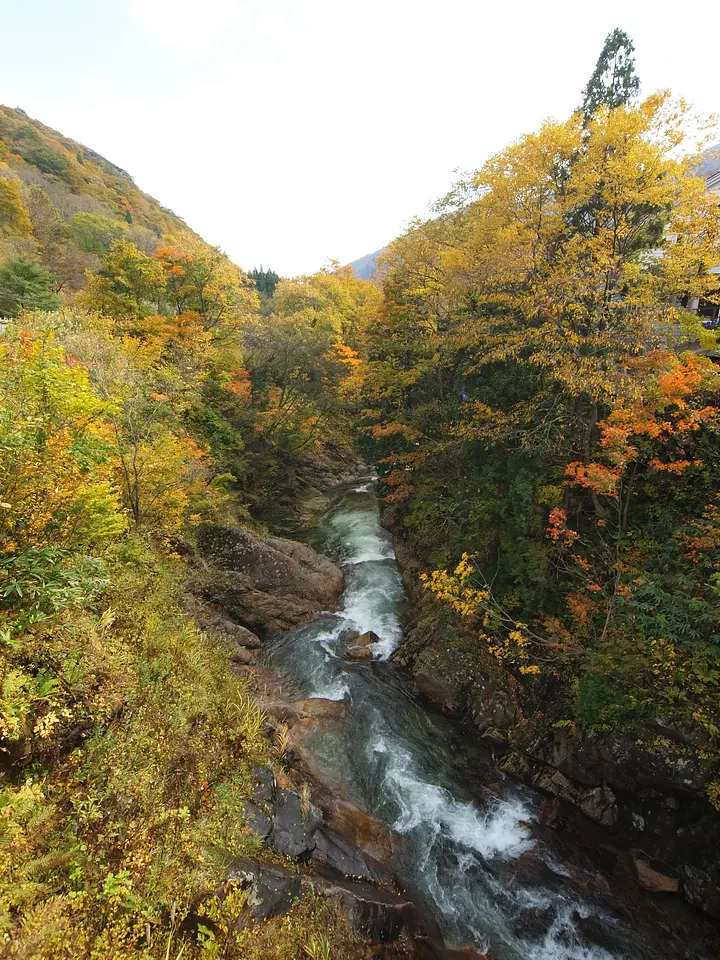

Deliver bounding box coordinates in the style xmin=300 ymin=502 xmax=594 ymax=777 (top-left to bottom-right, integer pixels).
xmin=315 ymin=875 xmax=443 ymax=944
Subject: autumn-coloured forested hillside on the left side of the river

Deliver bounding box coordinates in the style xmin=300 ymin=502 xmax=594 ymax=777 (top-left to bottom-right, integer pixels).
xmin=0 ymin=109 xmax=378 ymax=960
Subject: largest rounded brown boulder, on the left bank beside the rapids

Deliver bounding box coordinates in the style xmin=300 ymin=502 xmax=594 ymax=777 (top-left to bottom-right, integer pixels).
xmin=189 ymin=524 xmax=343 ymax=633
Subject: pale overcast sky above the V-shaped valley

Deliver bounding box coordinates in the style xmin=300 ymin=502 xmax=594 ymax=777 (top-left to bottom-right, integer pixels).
xmin=5 ymin=0 xmax=720 ymax=276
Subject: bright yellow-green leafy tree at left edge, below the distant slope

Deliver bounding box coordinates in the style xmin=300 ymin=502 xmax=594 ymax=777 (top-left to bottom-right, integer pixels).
xmin=0 ymin=329 xmax=126 ymax=557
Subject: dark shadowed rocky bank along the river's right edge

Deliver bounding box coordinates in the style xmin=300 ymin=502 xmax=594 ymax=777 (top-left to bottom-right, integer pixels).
xmin=387 ymin=516 xmax=720 ymax=919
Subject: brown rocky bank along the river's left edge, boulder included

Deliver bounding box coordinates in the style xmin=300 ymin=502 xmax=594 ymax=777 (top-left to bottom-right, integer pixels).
xmin=187 ymin=510 xmax=472 ymax=960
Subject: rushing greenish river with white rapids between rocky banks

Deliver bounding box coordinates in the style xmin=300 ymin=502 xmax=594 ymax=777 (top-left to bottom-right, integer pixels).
xmin=267 ymin=481 xmax=716 ymax=960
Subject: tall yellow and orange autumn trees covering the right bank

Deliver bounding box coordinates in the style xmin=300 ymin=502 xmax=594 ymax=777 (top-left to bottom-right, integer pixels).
xmin=361 ymin=63 xmax=720 ymax=848
